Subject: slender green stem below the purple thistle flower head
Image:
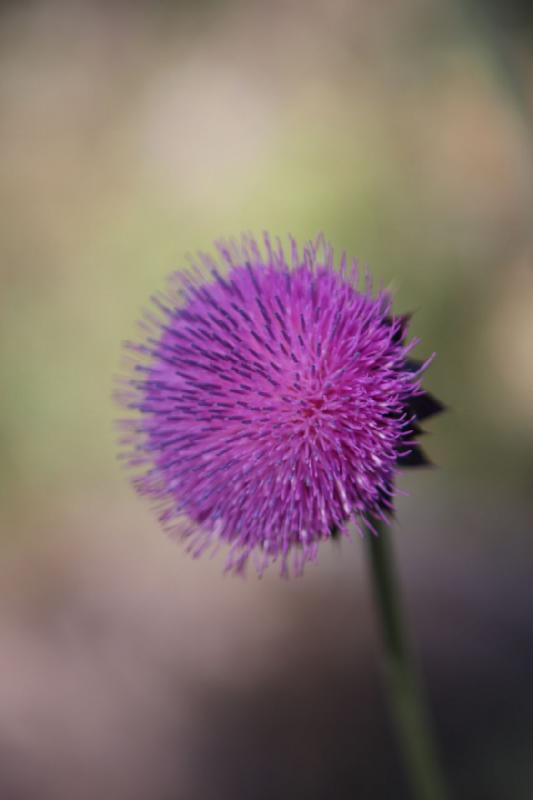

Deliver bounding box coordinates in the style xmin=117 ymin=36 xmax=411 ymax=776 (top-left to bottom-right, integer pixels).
xmin=366 ymin=523 xmax=448 ymax=800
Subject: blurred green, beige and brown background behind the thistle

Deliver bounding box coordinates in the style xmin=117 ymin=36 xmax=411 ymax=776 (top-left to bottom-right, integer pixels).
xmin=0 ymin=0 xmax=533 ymax=800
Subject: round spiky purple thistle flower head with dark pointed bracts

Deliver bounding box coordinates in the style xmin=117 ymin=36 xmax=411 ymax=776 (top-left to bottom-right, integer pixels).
xmin=119 ymin=236 xmax=442 ymax=574
